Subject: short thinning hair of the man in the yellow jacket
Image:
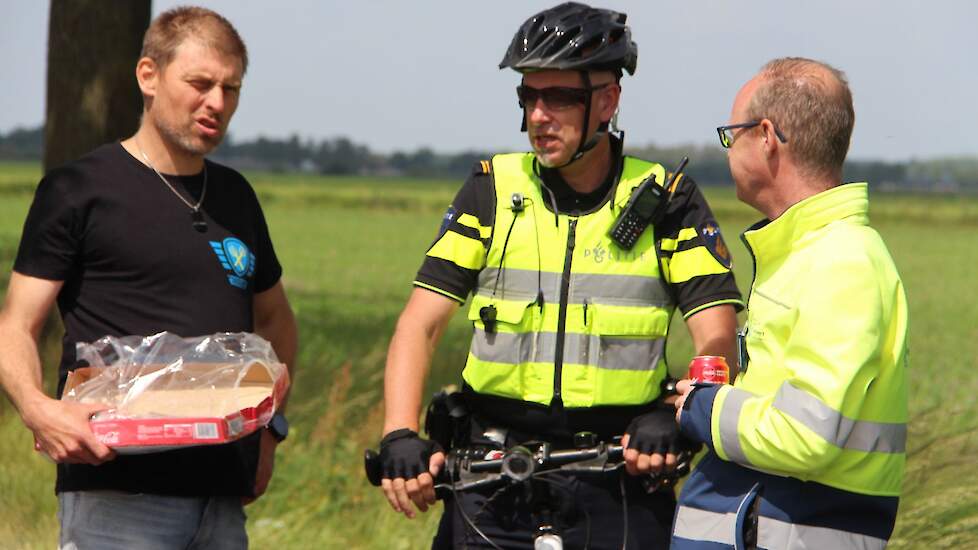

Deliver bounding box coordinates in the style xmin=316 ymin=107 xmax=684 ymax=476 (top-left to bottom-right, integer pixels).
xmin=747 ymin=57 xmax=856 ymax=178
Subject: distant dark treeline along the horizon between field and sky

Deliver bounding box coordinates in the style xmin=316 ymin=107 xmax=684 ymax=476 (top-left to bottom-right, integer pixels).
xmin=0 ymin=127 xmax=978 ymax=193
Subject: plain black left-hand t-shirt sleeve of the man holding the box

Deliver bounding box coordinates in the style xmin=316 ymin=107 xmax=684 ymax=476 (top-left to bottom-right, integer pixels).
xmin=14 ymin=167 xmax=84 ymax=281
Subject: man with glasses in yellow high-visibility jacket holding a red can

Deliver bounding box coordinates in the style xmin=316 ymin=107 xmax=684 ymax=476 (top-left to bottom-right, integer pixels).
xmin=672 ymin=58 xmax=907 ymax=550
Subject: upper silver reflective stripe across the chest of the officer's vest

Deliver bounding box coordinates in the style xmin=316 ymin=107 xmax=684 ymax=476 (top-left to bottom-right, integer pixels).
xmin=476 ymin=267 xmax=671 ymax=307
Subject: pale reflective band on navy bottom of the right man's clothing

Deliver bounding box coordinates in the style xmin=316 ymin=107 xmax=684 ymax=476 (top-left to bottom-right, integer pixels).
xmin=673 ymin=506 xmax=886 ymax=550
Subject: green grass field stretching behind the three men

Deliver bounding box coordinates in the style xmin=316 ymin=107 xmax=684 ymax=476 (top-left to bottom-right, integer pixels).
xmin=0 ymin=164 xmax=978 ymax=549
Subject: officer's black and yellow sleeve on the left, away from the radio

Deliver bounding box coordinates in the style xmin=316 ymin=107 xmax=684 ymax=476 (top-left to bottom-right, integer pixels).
xmin=414 ymin=161 xmax=496 ymax=303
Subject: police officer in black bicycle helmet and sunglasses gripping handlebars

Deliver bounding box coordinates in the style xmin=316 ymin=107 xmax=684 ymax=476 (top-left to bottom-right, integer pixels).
xmin=381 ymin=3 xmax=741 ymax=548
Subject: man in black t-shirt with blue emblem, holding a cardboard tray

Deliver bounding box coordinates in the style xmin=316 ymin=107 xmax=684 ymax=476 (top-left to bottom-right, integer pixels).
xmin=0 ymin=8 xmax=296 ymax=548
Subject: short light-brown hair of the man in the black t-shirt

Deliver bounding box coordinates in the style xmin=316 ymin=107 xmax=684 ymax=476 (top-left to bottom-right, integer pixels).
xmin=140 ymin=6 xmax=248 ymax=75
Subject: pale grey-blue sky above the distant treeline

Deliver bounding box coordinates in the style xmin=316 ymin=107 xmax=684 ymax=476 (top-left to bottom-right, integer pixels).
xmin=0 ymin=0 xmax=978 ymax=161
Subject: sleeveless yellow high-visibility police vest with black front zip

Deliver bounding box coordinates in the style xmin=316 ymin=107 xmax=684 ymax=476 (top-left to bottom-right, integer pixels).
xmin=460 ymin=154 xmax=688 ymax=407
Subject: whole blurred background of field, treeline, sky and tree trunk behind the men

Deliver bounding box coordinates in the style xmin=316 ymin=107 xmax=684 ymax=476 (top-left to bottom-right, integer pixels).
xmin=0 ymin=0 xmax=978 ymax=549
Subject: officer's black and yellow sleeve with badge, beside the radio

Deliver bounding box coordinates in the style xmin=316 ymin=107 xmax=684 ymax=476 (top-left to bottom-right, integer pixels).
xmin=656 ymin=178 xmax=744 ymax=318
